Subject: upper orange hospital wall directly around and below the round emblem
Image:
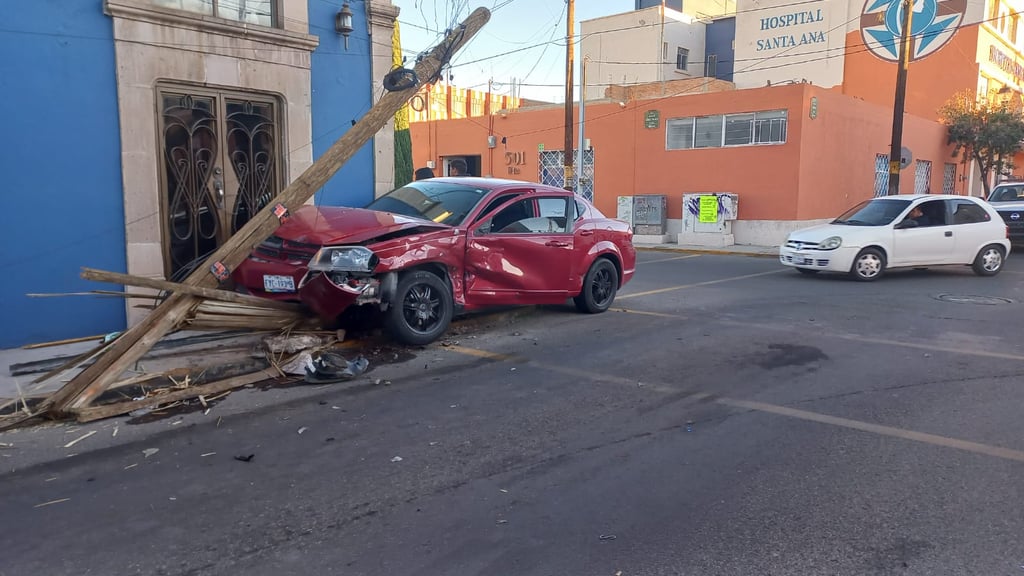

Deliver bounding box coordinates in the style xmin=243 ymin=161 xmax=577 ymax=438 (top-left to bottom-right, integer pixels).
xmin=836 ymin=25 xmax=979 ymax=119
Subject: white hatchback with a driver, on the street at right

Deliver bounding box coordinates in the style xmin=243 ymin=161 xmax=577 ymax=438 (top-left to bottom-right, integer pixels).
xmin=779 ymin=194 xmax=1010 ymax=282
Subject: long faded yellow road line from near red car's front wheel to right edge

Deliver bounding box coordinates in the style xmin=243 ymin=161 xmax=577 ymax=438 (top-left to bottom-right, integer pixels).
xmin=449 ymin=346 xmax=1024 ymax=462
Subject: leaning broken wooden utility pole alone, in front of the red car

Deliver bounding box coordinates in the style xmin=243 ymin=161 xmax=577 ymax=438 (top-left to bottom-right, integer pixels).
xmin=39 ymin=7 xmax=490 ymax=415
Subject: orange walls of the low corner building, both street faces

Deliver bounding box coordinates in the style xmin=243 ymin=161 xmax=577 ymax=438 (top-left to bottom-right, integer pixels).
xmin=411 ymin=84 xmax=952 ymax=220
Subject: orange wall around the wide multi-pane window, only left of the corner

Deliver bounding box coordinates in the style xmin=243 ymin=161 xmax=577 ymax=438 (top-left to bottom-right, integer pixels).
xmin=411 ymin=86 xmax=803 ymax=219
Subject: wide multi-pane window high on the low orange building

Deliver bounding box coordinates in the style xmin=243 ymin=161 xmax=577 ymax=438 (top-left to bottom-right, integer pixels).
xmin=666 ymin=110 xmax=787 ymax=150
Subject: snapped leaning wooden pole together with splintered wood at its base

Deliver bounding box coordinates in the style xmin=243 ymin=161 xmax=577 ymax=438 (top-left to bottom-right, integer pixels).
xmin=0 ymin=7 xmax=490 ymax=428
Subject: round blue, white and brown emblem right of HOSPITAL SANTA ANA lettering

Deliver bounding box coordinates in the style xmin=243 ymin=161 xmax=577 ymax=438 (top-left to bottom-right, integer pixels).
xmin=860 ymin=0 xmax=968 ymax=61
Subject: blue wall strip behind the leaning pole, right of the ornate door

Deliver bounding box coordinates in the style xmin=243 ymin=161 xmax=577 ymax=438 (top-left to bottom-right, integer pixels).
xmin=309 ymin=0 xmax=380 ymax=206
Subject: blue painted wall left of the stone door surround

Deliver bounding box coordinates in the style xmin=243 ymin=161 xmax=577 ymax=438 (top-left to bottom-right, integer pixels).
xmin=0 ymin=0 xmax=125 ymax=347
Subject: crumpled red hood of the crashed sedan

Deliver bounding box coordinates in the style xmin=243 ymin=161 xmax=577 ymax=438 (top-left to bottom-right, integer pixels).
xmin=274 ymin=206 xmax=451 ymax=246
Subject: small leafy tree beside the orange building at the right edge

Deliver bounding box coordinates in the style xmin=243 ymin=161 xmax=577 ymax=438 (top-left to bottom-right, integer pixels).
xmin=939 ymin=90 xmax=1024 ymax=198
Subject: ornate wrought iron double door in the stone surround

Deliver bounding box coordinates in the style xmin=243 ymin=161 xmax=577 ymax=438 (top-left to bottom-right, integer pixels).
xmin=160 ymin=89 xmax=282 ymax=278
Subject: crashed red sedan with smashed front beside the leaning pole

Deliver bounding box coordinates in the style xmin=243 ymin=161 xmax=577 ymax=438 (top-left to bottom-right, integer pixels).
xmin=233 ymin=177 xmax=636 ymax=344
